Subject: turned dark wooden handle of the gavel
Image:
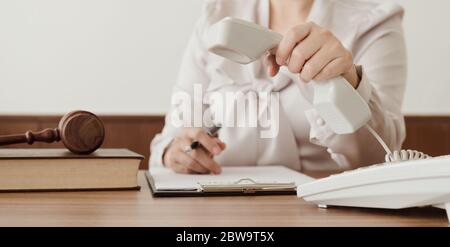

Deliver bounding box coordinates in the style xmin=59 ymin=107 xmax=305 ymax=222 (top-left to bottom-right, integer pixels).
xmin=0 ymin=129 xmax=61 ymax=146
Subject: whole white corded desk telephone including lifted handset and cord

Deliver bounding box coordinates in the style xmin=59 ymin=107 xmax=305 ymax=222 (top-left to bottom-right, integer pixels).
xmin=208 ymin=17 xmax=450 ymax=221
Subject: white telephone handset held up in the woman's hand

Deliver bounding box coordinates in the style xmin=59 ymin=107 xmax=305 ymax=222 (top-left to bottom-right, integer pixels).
xmin=208 ymin=17 xmax=371 ymax=134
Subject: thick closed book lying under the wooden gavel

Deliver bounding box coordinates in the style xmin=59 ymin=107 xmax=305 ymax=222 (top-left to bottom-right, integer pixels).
xmin=0 ymin=149 xmax=144 ymax=192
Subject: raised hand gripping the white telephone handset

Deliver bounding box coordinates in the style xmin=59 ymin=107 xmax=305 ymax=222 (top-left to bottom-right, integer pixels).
xmin=265 ymin=23 xmax=360 ymax=88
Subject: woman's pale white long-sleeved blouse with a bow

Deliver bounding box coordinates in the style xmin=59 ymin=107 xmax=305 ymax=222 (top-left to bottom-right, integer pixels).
xmin=150 ymin=0 xmax=407 ymax=171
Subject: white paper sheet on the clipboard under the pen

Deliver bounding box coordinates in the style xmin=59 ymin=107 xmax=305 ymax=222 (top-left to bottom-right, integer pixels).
xmin=150 ymin=166 xmax=314 ymax=191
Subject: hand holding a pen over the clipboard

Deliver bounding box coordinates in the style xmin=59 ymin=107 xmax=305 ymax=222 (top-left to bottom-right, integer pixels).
xmin=163 ymin=128 xmax=225 ymax=174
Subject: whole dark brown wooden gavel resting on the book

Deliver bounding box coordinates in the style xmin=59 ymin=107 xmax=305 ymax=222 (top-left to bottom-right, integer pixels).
xmin=0 ymin=111 xmax=105 ymax=154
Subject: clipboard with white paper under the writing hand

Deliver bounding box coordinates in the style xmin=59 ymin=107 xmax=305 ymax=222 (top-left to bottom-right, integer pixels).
xmin=146 ymin=166 xmax=314 ymax=196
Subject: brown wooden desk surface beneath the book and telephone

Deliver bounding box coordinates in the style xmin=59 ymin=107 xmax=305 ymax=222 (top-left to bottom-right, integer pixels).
xmin=0 ymin=172 xmax=448 ymax=226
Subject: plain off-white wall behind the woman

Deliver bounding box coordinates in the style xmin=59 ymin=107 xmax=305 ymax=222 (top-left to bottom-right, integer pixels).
xmin=0 ymin=0 xmax=450 ymax=115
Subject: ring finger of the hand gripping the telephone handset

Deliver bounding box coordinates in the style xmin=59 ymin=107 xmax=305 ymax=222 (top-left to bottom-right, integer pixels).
xmin=300 ymin=46 xmax=338 ymax=82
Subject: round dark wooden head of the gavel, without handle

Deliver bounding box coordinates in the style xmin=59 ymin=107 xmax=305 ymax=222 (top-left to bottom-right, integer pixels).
xmin=58 ymin=111 xmax=105 ymax=154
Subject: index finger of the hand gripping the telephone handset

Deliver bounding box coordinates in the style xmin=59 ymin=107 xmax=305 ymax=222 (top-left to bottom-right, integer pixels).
xmin=276 ymin=23 xmax=312 ymax=66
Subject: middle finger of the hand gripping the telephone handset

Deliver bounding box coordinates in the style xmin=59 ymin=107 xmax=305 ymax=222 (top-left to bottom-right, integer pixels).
xmin=288 ymin=33 xmax=325 ymax=74
